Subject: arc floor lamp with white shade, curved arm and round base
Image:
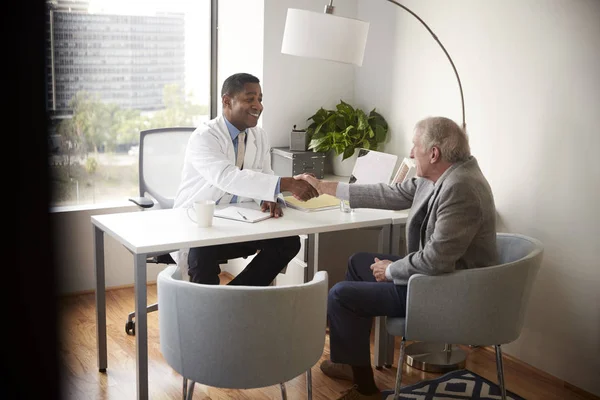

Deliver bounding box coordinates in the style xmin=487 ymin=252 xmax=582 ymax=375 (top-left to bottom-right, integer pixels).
xmin=281 ymin=0 xmax=467 ymax=372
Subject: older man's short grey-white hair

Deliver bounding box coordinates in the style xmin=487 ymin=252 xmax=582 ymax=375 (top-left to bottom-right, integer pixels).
xmin=415 ymin=117 xmax=471 ymax=163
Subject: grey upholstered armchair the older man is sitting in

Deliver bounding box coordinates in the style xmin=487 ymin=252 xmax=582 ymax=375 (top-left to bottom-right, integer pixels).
xmin=386 ymin=233 xmax=543 ymax=400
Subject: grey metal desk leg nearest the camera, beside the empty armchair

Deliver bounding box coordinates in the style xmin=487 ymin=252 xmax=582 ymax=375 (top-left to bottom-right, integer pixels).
xmin=133 ymin=254 xmax=148 ymax=400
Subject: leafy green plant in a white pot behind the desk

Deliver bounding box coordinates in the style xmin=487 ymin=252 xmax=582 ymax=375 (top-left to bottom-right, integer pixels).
xmin=306 ymin=100 xmax=388 ymax=176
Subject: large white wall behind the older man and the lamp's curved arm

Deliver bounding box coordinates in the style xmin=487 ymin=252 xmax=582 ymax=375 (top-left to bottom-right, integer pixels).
xmin=355 ymin=0 xmax=600 ymax=395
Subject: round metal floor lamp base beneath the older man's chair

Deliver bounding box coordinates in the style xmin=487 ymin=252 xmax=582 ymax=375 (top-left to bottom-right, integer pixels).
xmin=405 ymin=342 xmax=467 ymax=373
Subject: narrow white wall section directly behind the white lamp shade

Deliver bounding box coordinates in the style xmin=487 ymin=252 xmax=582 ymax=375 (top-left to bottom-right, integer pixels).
xmin=262 ymin=0 xmax=356 ymax=147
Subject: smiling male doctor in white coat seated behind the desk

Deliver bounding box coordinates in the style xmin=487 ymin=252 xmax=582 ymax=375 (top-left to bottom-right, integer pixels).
xmin=173 ymin=73 xmax=318 ymax=286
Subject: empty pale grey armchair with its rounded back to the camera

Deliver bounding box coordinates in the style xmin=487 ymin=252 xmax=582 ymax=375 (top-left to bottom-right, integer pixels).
xmin=157 ymin=266 xmax=328 ymax=399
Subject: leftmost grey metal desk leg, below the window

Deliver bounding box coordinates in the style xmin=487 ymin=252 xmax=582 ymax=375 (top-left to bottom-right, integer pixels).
xmin=94 ymin=226 xmax=108 ymax=372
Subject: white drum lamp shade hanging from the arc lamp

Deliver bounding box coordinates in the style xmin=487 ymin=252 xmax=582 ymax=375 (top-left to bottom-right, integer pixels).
xmin=281 ymin=8 xmax=369 ymax=67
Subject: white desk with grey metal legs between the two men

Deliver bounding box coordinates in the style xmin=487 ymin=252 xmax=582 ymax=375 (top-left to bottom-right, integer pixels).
xmin=91 ymin=208 xmax=408 ymax=399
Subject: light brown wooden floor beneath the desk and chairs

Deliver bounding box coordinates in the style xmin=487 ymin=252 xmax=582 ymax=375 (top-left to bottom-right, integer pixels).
xmin=57 ymin=278 xmax=596 ymax=400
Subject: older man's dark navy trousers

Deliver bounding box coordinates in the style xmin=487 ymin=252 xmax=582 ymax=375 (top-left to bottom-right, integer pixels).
xmin=327 ymin=253 xmax=407 ymax=366
